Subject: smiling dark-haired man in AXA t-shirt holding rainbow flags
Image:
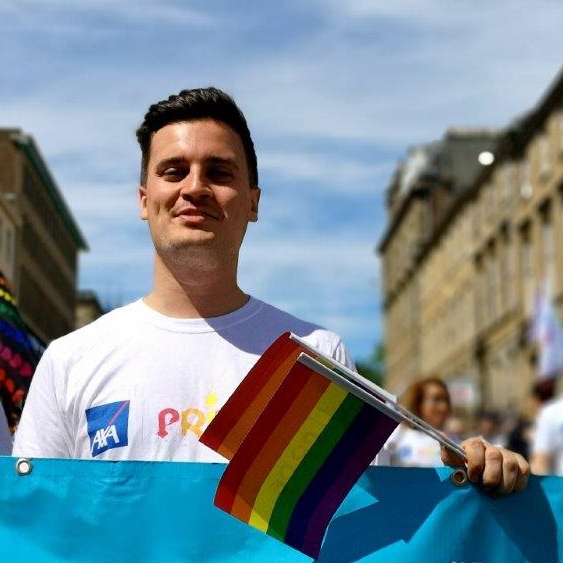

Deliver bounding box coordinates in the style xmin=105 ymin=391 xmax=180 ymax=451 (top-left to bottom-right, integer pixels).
xmin=14 ymin=88 xmax=528 ymax=492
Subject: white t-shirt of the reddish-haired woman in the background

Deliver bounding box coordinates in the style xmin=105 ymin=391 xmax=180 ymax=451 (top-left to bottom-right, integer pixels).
xmin=376 ymin=424 xmax=444 ymax=467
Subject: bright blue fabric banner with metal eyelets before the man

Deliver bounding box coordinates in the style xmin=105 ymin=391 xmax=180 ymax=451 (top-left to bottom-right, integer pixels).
xmin=0 ymin=457 xmax=563 ymax=563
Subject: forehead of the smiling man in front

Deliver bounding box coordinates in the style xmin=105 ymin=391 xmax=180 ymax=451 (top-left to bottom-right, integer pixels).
xmin=149 ymin=119 xmax=246 ymax=162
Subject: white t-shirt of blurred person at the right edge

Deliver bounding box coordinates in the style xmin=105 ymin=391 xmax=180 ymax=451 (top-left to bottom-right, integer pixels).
xmin=533 ymin=397 xmax=563 ymax=475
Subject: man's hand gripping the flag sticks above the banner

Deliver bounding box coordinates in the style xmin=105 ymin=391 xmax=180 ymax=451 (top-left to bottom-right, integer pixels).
xmin=442 ymin=437 xmax=530 ymax=495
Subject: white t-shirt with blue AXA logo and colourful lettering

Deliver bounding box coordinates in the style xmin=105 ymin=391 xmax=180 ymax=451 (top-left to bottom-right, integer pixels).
xmin=13 ymin=298 xmax=353 ymax=462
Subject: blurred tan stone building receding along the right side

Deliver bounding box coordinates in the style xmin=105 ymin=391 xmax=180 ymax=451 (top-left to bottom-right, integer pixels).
xmin=379 ymin=66 xmax=563 ymax=418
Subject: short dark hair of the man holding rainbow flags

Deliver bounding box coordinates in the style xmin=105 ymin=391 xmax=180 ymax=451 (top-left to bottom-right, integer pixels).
xmin=137 ymin=87 xmax=258 ymax=186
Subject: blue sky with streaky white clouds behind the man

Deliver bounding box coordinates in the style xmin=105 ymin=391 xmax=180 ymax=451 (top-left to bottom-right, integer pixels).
xmin=0 ymin=0 xmax=563 ymax=360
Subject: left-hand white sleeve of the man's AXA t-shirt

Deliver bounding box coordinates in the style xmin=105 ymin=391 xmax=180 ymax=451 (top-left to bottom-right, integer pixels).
xmin=12 ymin=348 xmax=71 ymax=458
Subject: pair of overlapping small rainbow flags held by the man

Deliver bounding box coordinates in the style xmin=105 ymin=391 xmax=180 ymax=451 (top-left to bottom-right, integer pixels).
xmin=201 ymin=334 xmax=398 ymax=557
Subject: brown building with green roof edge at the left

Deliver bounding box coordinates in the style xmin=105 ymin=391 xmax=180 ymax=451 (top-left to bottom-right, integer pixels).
xmin=0 ymin=129 xmax=87 ymax=343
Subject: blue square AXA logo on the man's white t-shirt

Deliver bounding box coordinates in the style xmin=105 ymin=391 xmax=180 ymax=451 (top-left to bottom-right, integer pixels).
xmin=86 ymin=401 xmax=129 ymax=457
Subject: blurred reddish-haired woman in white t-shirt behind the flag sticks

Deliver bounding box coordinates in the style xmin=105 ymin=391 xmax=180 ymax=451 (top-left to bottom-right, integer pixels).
xmin=378 ymin=377 xmax=451 ymax=467
